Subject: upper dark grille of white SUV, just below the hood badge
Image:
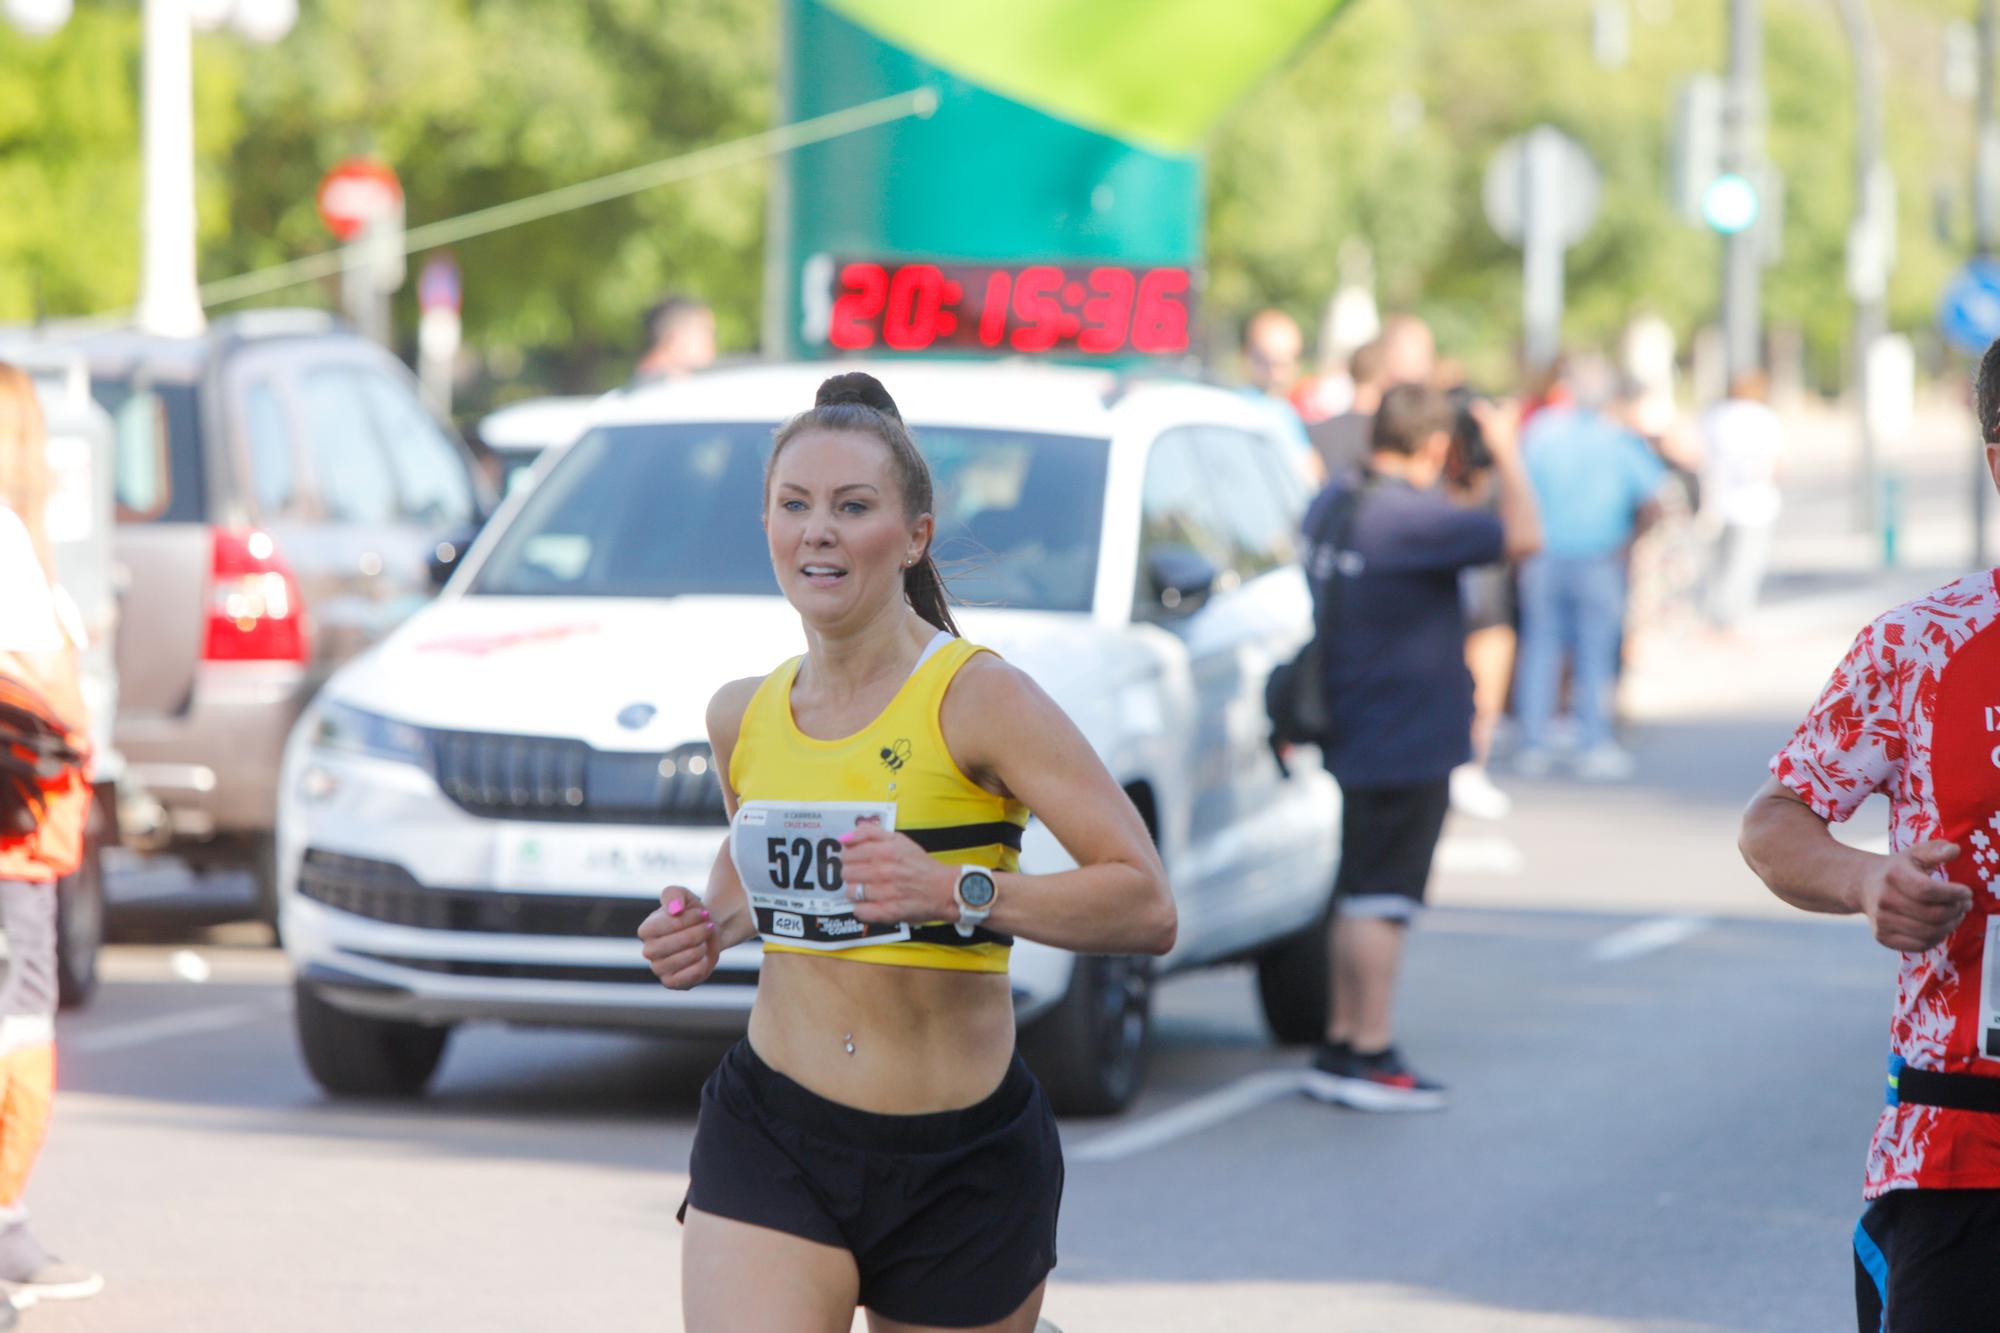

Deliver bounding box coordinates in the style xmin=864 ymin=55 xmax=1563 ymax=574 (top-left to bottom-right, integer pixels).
xmin=430 ymin=731 xmax=728 ymax=825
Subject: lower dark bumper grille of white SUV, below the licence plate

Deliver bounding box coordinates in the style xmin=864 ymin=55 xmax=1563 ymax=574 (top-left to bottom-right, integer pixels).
xmin=298 ymin=847 xmax=654 ymax=940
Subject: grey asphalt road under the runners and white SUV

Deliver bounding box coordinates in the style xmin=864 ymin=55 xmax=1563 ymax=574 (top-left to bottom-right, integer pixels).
xmin=26 ymin=640 xmax=1894 ymax=1333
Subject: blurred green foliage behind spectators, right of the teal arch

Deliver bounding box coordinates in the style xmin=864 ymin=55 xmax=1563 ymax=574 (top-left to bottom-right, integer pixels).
xmin=1208 ymin=0 xmax=1974 ymax=394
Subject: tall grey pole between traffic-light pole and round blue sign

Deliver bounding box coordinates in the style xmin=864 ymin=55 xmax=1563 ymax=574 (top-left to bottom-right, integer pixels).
xmin=1838 ymin=0 xmax=1880 ymax=530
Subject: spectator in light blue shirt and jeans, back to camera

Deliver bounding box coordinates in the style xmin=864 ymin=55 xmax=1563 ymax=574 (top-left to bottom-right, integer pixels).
xmin=1514 ymin=360 xmax=1666 ymax=781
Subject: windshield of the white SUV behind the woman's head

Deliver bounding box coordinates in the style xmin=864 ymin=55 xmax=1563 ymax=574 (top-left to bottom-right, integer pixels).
xmin=472 ymin=422 xmax=1110 ymax=610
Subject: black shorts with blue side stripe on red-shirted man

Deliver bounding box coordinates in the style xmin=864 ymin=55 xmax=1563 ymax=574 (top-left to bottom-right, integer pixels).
xmin=1854 ymin=1189 xmax=2000 ymax=1333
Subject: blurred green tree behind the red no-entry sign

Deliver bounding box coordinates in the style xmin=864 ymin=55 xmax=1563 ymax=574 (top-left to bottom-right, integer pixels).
xmin=219 ymin=0 xmax=774 ymax=396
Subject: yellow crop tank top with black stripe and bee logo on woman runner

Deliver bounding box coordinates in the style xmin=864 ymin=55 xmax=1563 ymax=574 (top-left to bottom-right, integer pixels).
xmin=730 ymin=638 xmax=1028 ymax=973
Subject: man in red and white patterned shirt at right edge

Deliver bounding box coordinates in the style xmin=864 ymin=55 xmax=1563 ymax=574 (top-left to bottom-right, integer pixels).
xmin=1740 ymin=342 xmax=2000 ymax=1333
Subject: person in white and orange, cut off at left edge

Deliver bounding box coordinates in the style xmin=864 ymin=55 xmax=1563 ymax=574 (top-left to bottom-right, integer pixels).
xmin=0 ymin=364 xmax=104 ymax=1329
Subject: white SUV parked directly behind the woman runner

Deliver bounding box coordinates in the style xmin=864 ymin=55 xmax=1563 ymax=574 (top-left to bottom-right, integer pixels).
xmin=278 ymin=364 xmax=1340 ymax=1113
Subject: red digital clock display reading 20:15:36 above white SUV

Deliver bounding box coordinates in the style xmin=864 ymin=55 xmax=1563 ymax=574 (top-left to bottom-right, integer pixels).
xmin=826 ymin=260 xmax=1192 ymax=356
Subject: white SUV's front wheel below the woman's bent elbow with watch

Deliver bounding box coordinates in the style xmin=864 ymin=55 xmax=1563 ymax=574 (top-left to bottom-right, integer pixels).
xmin=1020 ymin=955 xmax=1152 ymax=1115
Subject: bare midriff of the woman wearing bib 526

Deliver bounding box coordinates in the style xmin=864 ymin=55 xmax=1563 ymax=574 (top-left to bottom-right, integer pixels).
xmin=750 ymin=953 xmax=1014 ymax=1115
